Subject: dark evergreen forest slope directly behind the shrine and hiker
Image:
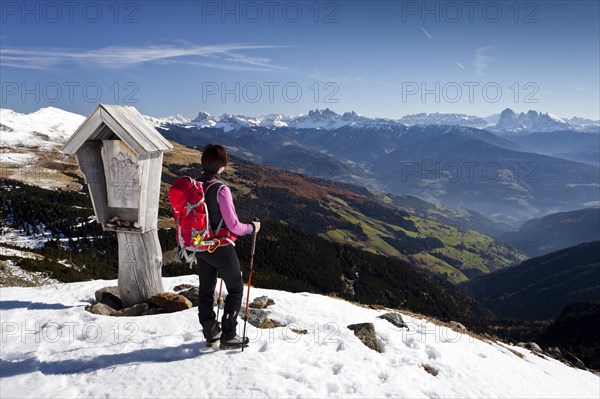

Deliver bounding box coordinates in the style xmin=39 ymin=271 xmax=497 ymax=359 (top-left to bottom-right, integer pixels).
xmin=0 ymin=180 xmax=492 ymax=327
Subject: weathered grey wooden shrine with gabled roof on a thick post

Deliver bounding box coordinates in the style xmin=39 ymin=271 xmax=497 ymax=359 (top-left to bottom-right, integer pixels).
xmin=62 ymin=104 xmax=173 ymax=306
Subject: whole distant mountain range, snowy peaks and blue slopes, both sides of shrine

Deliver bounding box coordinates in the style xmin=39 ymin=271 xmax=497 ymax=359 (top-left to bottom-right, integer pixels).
xmin=0 ymin=108 xmax=600 ymax=230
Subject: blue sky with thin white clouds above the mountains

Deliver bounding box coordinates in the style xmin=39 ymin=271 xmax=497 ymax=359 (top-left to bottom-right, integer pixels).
xmin=0 ymin=1 xmax=600 ymax=119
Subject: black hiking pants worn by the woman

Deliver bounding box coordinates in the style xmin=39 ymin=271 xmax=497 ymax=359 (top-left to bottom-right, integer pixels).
xmin=196 ymin=245 xmax=244 ymax=340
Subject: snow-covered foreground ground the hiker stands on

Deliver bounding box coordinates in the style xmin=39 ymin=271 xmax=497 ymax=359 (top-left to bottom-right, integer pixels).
xmin=0 ymin=276 xmax=600 ymax=398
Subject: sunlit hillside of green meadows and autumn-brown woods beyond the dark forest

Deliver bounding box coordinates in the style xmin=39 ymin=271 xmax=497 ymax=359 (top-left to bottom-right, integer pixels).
xmin=161 ymin=145 xmax=524 ymax=283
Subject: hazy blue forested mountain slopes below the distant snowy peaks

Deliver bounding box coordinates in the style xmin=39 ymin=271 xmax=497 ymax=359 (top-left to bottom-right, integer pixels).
xmin=158 ymin=112 xmax=600 ymax=228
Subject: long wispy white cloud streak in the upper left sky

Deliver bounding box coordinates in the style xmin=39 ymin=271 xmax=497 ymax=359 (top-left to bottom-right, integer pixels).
xmin=0 ymin=44 xmax=287 ymax=72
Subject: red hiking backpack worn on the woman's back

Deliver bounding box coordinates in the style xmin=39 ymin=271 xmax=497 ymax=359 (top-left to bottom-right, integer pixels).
xmin=169 ymin=176 xmax=236 ymax=266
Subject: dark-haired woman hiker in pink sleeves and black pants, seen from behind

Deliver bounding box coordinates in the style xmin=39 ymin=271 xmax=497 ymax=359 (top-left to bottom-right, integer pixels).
xmin=196 ymin=144 xmax=260 ymax=348
